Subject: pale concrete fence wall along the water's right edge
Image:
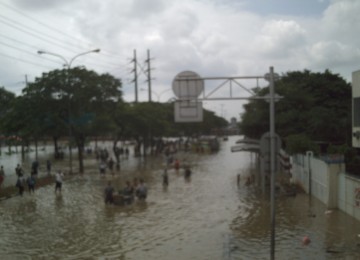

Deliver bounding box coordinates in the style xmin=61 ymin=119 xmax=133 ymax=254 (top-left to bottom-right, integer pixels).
xmin=290 ymin=152 xmax=360 ymax=220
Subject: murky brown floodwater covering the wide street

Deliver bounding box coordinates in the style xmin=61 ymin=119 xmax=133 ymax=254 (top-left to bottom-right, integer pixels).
xmin=0 ymin=137 xmax=360 ymax=260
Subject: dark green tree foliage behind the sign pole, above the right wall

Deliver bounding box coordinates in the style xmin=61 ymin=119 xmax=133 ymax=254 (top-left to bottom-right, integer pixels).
xmin=240 ymin=70 xmax=351 ymax=153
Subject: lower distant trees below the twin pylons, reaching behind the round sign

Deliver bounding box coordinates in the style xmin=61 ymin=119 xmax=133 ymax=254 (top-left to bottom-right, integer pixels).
xmin=114 ymin=102 xmax=227 ymax=154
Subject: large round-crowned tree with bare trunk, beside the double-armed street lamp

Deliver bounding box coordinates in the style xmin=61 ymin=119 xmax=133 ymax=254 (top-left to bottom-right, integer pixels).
xmin=23 ymin=67 xmax=122 ymax=173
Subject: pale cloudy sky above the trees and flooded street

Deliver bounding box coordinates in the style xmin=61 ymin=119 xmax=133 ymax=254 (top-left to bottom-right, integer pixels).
xmin=0 ymin=0 xmax=360 ymax=121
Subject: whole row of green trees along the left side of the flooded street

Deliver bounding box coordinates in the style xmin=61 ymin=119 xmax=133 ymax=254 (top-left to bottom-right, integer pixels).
xmin=0 ymin=67 xmax=227 ymax=172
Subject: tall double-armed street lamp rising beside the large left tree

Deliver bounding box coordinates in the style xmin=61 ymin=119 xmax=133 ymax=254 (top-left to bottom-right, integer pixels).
xmin=37 ymin=49 xmax=100 ymax=173
